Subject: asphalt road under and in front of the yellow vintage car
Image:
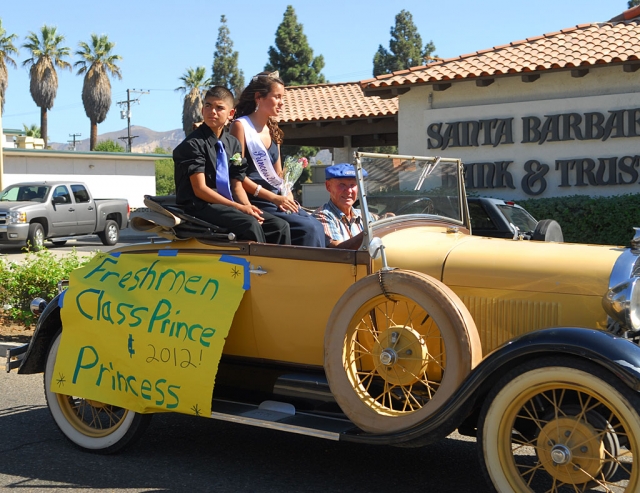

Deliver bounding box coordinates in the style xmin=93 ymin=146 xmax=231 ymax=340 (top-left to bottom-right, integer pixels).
xmin=0 ymin=368 xmax=488 ymax=493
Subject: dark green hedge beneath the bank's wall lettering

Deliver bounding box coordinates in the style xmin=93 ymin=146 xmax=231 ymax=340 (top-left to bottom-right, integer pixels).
xmin=518 ymin=194 xmax=640 ymax=246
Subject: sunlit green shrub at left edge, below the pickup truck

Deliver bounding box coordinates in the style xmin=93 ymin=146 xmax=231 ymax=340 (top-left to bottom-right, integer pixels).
xmin=0 ymin=249 xmax=90 ymax=327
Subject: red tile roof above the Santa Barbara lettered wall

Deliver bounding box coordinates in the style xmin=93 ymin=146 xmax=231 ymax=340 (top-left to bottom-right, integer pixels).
xmin=360 ymin=19 xmax=640 ymax=94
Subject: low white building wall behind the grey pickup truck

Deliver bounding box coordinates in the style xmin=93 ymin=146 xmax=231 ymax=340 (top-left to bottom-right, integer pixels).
xmin=2 ymin=149 xmax=159 ymax=208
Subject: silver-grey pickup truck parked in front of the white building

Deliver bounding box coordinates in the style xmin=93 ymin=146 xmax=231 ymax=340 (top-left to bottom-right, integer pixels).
xmin=0 ymin=181 xmax=129 ymax=251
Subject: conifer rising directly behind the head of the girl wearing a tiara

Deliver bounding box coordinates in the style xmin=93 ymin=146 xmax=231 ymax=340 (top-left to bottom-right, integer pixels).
xmin=264 ymin=5 xmax=327 ymax=86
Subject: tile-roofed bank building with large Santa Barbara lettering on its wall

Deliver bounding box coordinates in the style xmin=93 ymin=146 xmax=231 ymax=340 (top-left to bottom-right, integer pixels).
xmin=360 ymin=7 xmax=640 ymax=198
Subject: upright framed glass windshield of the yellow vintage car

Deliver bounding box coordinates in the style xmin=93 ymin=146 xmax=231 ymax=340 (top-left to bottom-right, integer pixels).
xmin=360 ymin=154 xmax=463 ymax=222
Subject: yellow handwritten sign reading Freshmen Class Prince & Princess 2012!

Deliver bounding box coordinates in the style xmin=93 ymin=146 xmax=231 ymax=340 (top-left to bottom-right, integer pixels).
xmin=51 ymin=250 xmax=249 ymax=416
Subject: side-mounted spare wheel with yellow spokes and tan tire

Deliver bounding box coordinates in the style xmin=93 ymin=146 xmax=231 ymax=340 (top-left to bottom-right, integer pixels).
xmin=324 ymin=271 xmax=482 ymax=433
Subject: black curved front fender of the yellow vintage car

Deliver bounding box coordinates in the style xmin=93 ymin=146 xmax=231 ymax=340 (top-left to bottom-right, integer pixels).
xmin=341 ymin=327 xmax=640 ymax=445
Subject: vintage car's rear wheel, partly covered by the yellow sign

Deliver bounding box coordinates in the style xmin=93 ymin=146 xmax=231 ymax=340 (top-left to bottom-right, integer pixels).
xmin=44 ymin=332 xmax=152 ymax=454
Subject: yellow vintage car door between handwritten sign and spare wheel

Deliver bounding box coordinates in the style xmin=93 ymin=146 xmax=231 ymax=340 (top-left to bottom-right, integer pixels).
xmin=231 ymin=243 xmax=369 ymax=366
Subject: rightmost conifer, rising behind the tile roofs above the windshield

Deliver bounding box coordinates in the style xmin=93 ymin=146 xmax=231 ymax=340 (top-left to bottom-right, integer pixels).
xmin=373 ymin=10 xmax=436 ymax=77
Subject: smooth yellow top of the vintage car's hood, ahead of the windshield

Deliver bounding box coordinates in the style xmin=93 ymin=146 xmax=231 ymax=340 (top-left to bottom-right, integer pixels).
xmin=384 ymin=227 xmax=624 ymax=296
